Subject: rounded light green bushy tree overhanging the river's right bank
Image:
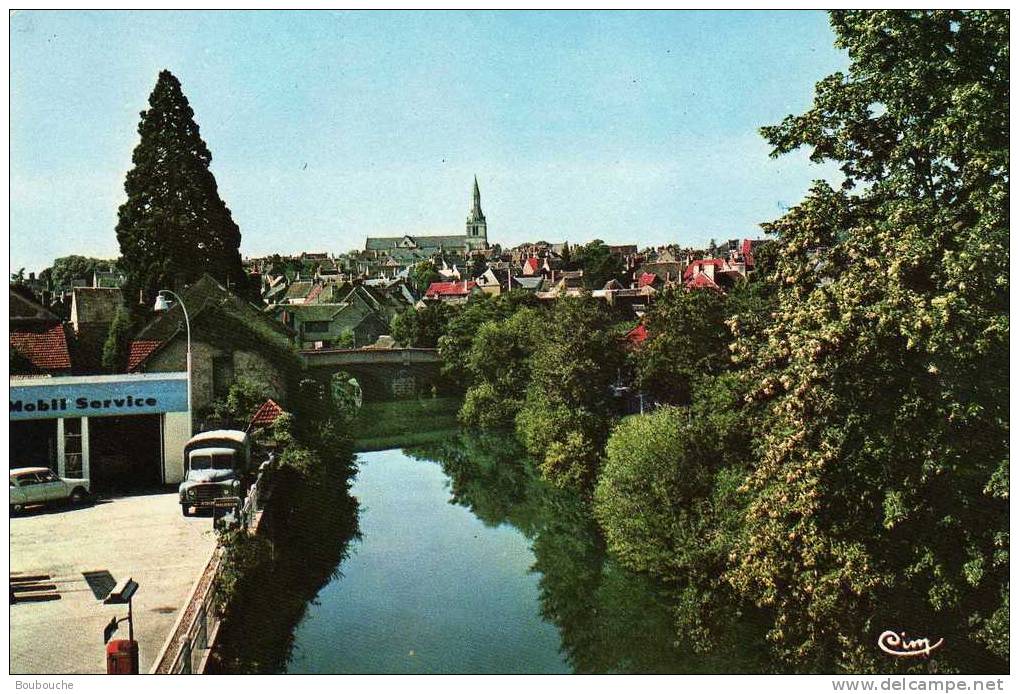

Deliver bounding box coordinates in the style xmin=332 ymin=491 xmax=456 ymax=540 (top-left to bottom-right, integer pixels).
xmin=594 ymin=374 xmax=763 ymax=652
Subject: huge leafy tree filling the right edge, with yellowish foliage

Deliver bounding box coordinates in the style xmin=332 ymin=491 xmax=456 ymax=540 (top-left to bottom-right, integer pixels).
xmin=726 ymin=10 xmax=1009 ymax=672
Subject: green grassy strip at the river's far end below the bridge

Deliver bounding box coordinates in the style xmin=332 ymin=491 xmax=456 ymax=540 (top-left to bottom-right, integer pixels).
xmin=352 ymin=397 xmax=461 ymax=451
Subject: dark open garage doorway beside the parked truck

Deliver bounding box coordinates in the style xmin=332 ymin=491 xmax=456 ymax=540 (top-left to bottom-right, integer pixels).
xmin=89 ymin=415 xmax=163 ymax=493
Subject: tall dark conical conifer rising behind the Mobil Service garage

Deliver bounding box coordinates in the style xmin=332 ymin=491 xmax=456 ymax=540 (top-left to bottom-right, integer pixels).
xmin=117 ymin=70 xmax=248 ymax=302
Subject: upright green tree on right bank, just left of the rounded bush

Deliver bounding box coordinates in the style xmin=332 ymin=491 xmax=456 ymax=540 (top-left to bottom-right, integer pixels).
xmin=517 ymin=295 xmax=623 ymax=489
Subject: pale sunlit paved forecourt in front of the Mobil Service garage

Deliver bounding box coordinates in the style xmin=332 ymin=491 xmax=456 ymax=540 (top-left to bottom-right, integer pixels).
xmin=10 ymin=493 xmax=216 ymax=674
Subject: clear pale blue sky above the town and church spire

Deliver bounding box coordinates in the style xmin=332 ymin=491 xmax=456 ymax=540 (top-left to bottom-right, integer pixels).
xmin=10 ymin=11 xmax=848 ymax=272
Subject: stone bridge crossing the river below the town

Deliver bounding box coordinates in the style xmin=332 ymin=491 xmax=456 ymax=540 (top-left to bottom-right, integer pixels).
xmin=301 ymin=348 xmax=441 ymax=401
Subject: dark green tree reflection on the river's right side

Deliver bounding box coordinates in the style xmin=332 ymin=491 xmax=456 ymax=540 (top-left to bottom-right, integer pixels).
xmin=406 ymin=434 xmax=756 ymax=673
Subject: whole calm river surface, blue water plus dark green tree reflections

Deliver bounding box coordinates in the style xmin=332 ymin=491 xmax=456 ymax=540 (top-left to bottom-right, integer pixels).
xmin=287 ymin=436 xmax=717 ymax=674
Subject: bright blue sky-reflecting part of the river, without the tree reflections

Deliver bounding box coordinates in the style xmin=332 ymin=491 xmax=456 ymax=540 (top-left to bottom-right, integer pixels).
xmin=287 ymin=450 xmax=570 ymax=673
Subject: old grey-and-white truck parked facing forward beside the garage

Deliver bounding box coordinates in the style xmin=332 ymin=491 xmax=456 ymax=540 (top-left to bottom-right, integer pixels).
xmin=177 ymin=429 xmax=252 ymax=516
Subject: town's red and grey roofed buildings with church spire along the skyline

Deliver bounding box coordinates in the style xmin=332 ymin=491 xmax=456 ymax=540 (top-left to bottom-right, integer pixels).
xmin=10 ymin=177 xmax=768 ymax=374
